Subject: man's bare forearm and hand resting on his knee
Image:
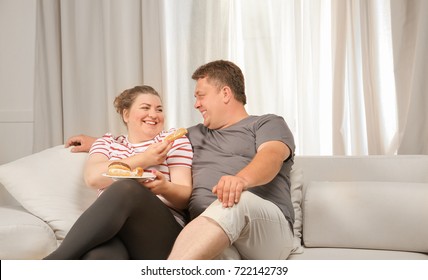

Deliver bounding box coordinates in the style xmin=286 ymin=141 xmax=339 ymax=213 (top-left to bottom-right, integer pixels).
xmin=213 ymin=141 xmax=291 ymax=207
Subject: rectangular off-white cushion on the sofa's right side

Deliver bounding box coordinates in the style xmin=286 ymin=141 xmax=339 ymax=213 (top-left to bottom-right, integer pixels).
xmin=303 ymin=181 xmax=428 ymax=253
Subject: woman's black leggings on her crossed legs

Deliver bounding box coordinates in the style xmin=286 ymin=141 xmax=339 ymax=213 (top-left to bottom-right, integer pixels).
xmin=45 ymin=180 xmax=182 ymax=260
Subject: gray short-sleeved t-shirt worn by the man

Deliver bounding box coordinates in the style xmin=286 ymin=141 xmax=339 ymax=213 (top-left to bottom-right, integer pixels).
xmin=188 ymin=114 xmax=295 ymax=224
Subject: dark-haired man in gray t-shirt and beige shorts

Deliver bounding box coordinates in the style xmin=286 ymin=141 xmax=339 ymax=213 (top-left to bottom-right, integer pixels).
xmin=67 ymin=60 xmax=295 ymax=259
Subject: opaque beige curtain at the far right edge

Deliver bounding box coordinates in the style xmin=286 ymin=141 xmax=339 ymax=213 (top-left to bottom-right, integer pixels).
xmin=391 ymin=0 xmax=428 ymax=154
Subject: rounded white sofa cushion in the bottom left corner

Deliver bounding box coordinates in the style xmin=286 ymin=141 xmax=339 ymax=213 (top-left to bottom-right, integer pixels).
xmin=0 ymin=207 xmax=57 ymax=260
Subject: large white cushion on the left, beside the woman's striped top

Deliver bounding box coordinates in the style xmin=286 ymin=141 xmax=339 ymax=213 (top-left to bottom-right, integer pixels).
xmin=0 ymin=145 xmax=96 ymax=240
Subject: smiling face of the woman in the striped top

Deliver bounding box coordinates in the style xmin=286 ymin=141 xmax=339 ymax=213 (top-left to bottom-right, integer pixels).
xmin=123 ymin=93 xmax=165 ymax=143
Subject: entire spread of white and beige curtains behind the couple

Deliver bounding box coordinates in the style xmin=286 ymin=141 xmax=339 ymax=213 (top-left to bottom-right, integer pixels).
xmin=34 ymin=0 xmax=428 ymax=155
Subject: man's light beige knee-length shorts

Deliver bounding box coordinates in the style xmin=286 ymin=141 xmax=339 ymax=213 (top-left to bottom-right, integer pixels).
xmin=201 ymin=191 xmax=293 ymax=260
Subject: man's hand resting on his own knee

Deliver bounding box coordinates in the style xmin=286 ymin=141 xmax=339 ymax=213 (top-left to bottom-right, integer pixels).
xmin=213 ymin=175 xmax=248 ymax=207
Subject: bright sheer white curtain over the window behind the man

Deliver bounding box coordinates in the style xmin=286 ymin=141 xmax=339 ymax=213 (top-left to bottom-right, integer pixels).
xmin=165 ymin=0 xmax=398 ymax=155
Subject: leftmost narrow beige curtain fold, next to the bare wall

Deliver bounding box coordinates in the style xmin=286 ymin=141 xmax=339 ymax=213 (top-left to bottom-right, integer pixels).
xmin=33 ymin=1 xmax=64 ymax=152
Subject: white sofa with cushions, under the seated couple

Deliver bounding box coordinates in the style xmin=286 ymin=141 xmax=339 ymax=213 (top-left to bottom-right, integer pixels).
xmin=0 ymin=146 xmax=428 ymax=260
